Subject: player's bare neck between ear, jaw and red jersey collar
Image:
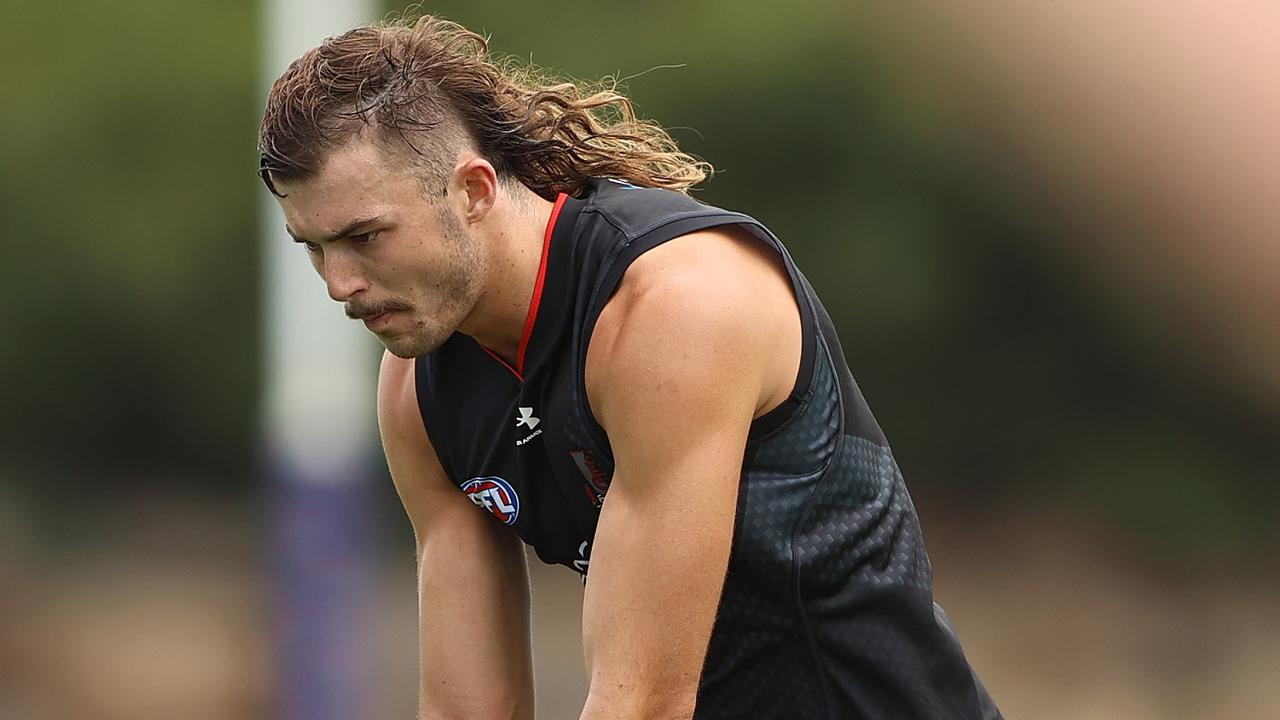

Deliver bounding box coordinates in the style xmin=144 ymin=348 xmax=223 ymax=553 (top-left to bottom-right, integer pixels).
xmin=458 ymin=183 xmax=553 ymax=368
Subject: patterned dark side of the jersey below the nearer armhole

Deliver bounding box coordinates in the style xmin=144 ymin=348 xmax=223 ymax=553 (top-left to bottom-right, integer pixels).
xmin=696 ymin=347 xmax=978 ymax=720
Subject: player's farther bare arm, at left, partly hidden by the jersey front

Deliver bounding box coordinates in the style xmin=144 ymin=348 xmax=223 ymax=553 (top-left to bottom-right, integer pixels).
xmin=378 ymin=354 xmax=534 ymax=720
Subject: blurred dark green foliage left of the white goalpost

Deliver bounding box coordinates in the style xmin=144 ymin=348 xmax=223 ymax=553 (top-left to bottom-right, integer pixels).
xmin=0 ymin=1 xmax=259 ymax=478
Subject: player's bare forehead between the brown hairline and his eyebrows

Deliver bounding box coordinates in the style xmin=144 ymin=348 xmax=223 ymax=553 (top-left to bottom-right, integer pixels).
xmin=276 ymin=141 xmax=422 ymax=237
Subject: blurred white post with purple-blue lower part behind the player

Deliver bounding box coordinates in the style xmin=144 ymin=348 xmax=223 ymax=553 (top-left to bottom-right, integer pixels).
xmin=261 ymin=0 xmax=379 ymax=720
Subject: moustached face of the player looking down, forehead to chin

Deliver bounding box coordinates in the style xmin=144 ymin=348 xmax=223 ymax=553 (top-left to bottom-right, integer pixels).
xmin=276 ymin=141 xmax=486 ymax=357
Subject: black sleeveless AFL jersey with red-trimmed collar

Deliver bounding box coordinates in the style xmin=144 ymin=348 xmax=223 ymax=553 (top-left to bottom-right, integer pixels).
xmin=416 ymin=181 xmax=1000 ymax=720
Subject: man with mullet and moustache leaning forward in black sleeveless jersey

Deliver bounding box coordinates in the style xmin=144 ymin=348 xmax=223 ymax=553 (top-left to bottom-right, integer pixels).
xmin=259 ymin=17 xmax=998 ymax=720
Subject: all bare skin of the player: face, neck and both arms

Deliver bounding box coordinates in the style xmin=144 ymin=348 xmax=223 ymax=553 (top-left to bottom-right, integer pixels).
xmin=278 ymin=141 xmax=801 ymax=720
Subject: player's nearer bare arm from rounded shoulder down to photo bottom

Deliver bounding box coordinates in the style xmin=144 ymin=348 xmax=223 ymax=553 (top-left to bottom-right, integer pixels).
xmin=582 ymin=232 xmax=800 ymax=720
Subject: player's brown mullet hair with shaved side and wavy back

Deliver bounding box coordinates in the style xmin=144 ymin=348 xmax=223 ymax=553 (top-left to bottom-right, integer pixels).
xmin=257 ymin=15 xmax=713 ymax=200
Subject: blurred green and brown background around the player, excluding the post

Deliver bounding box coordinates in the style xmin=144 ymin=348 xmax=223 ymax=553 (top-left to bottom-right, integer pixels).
xmin=0 ymin=0 xmax=1280 ymax=720
